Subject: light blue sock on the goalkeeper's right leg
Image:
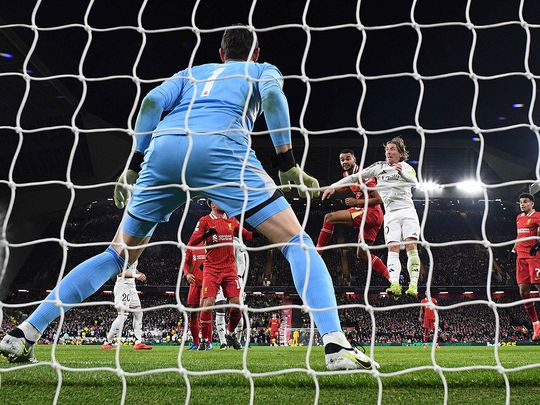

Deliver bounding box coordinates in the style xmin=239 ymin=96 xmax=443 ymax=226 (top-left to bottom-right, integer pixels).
xmin=282 ymin=233 xmax=341 ymax=336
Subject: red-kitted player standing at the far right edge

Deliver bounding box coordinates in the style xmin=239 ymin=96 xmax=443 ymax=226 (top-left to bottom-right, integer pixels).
xmin=511 ymin=193 xmax=540 ymax=340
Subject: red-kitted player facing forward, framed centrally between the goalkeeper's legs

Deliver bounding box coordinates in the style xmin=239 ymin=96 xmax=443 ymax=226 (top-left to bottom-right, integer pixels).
xmin=188 ymin=202 xmax=253 ymax=350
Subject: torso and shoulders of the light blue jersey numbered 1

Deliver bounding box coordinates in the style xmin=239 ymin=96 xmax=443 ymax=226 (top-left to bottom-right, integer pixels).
xmin=146 ymin=61 xmax=288 ymax=143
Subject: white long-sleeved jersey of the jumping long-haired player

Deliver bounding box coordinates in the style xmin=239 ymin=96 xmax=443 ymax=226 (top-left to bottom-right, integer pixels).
xmin=332 ymin=161 xmax=417 ymax=212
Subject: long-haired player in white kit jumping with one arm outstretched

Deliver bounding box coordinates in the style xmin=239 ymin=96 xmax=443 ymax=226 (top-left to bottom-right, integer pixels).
xmin=322 ymin=137 xmax=420 ymax=297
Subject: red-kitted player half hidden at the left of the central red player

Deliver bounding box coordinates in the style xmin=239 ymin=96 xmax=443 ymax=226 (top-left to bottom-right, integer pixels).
xmin=184 ymin=242 xmax=206 ymax=350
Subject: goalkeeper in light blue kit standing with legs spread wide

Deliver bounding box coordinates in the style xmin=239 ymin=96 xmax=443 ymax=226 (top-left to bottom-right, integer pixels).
xmin=0 ymin=25 xmax=377 ymax=370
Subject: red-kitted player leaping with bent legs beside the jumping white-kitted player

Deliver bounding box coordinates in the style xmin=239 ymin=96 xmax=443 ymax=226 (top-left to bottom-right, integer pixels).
xmin=317 ymin=149 xmax=390 ymax=280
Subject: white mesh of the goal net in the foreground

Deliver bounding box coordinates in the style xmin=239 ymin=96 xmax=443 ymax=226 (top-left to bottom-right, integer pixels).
xmin=0 ymin=0 xmax=540 ymax=404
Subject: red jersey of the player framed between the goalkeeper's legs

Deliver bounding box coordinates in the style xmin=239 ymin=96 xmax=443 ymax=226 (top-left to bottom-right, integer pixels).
xmin=189 ymin=213 xmax=253 ymax=272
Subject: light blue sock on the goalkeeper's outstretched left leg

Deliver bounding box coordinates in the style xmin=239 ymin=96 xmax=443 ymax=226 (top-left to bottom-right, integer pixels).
xmin=27 ymin=246 xmax=124 ymax=333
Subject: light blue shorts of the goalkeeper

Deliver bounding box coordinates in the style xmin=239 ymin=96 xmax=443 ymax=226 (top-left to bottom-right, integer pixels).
xmin=128 ymin=135 xmax=289 ymax=227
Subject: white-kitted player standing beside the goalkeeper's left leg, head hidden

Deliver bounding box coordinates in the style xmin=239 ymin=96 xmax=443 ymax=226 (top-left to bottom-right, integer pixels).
xmin=101 ymin=261 xmax=152 ymax=350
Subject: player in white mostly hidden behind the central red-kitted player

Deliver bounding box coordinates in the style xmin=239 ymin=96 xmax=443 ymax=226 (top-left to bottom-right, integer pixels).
xmin=216 ymin=237 xmax=249 ymax=350
